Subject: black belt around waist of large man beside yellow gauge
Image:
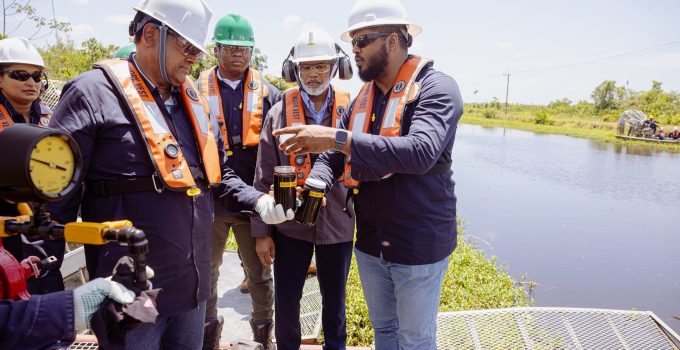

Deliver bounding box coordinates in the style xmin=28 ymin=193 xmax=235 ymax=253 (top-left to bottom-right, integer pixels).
xmin=87 ymin=167 xmax=204 ymax=197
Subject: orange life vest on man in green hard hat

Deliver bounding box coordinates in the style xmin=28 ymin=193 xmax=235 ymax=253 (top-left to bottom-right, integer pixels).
xmin=200 ymin=68 xmax=269 ymax=150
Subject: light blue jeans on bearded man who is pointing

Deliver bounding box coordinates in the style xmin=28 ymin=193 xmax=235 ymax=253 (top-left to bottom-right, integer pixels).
xmin=354 ymin=248 xmax=449 ymax=350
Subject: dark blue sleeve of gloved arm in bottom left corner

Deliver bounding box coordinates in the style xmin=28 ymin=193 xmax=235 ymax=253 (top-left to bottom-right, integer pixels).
xmin=0 ymin=291 xmax=76 ymax=350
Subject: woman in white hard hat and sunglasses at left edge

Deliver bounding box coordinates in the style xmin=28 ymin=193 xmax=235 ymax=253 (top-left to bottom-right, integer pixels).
xmin=0 ymin=38 xmax=56 ymax=294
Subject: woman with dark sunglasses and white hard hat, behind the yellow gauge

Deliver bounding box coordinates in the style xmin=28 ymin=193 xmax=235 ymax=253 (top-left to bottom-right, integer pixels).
xmin=0 ymin=38 xmax=64 ymax=294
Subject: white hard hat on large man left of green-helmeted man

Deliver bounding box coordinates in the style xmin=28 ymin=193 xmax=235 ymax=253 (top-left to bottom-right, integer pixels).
xmin=133 ymin=0 xmax=212 ymax=54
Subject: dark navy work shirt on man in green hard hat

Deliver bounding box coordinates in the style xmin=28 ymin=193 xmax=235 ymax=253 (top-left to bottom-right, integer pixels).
xmin=196 ymin=67 xmax=281 ymax=216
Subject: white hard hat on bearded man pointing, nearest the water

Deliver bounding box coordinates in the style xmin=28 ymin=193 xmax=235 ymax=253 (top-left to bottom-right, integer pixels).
xmin=340 ymin=0 xmax=423 ymax=42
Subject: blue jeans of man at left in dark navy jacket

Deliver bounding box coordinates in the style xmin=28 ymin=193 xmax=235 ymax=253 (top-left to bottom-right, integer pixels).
xmin=125 ymin=300 xmax=205 ymax=350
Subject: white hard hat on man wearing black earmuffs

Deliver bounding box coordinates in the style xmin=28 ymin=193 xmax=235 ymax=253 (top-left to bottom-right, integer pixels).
xmin=292 ymin=29 xmax=338 ymax=63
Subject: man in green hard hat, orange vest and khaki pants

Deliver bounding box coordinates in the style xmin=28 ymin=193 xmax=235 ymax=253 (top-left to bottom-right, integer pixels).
xmin=198 ymin=14 xmax=281 ymax=349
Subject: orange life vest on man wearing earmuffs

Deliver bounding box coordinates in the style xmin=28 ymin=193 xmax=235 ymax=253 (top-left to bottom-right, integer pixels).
xmin=283 ymin=87 xmax=349 ymax=186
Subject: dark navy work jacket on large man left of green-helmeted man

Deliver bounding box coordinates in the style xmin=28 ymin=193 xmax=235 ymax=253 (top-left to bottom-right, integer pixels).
xmin=48 ymin=58 xmax=261 ymax=317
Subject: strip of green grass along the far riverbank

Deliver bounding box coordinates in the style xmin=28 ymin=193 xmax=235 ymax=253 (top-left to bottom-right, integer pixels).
xmin=461 ymin=108 xmax=680 ymax=153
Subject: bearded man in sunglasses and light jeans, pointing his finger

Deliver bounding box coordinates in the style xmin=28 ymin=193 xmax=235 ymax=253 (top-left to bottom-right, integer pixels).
xmin=274 ymin=0 xmax=463 ymax=350
